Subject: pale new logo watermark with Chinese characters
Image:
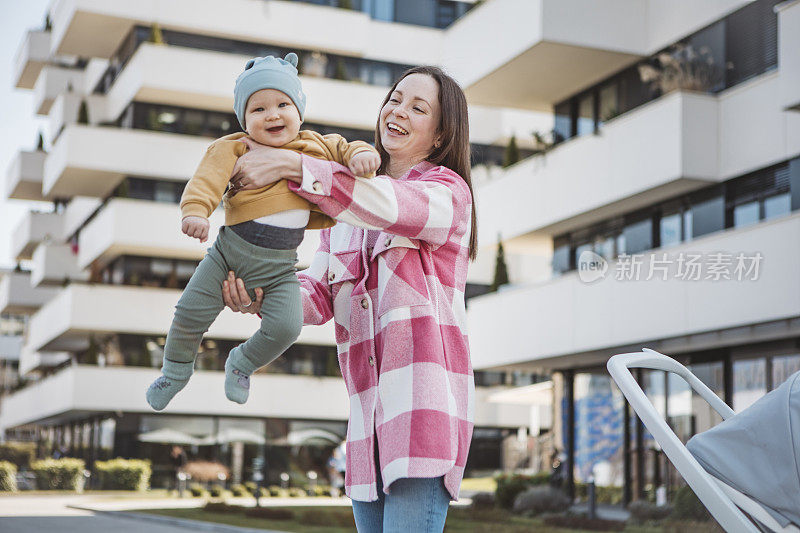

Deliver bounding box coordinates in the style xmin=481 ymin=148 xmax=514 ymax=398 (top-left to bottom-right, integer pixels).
xmin=578 ymin=250 xmax=764 ymax=283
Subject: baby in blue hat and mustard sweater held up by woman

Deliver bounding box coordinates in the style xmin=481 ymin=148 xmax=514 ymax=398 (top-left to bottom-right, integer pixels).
xmin=147 ymin=53 xmax=380 ymax=411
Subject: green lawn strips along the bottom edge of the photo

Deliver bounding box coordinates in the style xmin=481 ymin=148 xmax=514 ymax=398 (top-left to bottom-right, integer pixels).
xmin=134 ymin=507 xmax=722 ymax=533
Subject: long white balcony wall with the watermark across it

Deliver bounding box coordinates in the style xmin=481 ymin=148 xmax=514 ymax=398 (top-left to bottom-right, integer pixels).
xmin=468 ymin=213 xmax=800 ymax=369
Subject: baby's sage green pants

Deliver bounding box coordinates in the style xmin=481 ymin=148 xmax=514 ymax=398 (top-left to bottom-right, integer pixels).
xmin=162 ymin=227 xmax=303 ymax=380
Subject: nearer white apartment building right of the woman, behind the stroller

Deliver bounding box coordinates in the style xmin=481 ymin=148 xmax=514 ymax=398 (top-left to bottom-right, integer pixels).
xmin=462 ymin=0 xmax=800 ymax=501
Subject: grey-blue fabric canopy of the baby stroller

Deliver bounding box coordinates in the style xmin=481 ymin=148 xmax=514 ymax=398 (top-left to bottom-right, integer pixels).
xmin=686 ymin=372 xmax=800 ymax=527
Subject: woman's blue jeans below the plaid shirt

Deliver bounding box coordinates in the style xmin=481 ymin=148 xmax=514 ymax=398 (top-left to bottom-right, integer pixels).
xmin=353 ymin=446 xmax=450 ymax=533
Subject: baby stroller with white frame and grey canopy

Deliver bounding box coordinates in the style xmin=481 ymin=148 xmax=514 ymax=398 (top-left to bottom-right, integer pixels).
xmin=607 ymin=348 xmax=800 ymax=533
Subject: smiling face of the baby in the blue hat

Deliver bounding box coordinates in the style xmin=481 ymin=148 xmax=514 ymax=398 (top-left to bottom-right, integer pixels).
xmin=244 ymin=89 xmax=302 ymax=146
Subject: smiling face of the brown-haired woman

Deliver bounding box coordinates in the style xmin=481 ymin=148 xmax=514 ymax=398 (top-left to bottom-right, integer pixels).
xmin=379 ymin=73 xmax=441 ymax=165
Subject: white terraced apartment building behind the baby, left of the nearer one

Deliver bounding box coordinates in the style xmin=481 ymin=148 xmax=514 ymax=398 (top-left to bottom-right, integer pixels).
xmin=0 ymin=0 xmax=541 ymax=486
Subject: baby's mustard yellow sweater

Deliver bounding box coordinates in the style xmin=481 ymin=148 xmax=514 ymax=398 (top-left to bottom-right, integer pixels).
xmin=181 ymin=130 xmax=375 ymax=229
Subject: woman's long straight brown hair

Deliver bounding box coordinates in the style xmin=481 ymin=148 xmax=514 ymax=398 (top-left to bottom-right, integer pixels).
xmin=375 ymin=66 xmax=478 ymax=260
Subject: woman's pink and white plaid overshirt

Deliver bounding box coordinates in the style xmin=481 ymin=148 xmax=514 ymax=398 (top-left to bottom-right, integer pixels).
xmin=290 ymin=156 xmax=475 ymax=501
